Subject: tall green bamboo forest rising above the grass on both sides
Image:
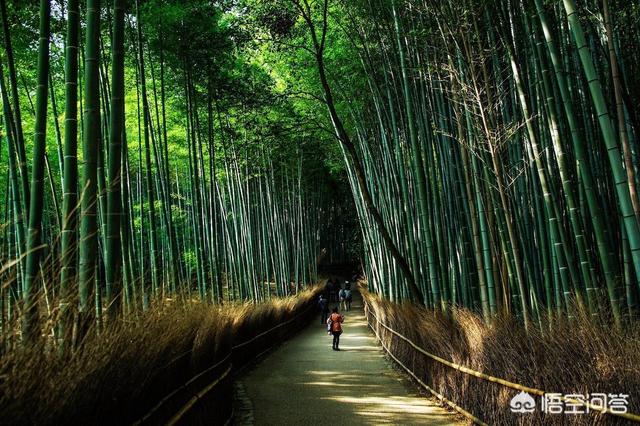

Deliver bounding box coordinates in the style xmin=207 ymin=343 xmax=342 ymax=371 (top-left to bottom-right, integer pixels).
xmin=0 ymin=0 xmax=640 ymax=347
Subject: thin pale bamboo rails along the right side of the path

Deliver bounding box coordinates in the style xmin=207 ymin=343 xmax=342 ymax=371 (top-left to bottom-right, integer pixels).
xmin=363 ymin=297 xmax=640 ymax=425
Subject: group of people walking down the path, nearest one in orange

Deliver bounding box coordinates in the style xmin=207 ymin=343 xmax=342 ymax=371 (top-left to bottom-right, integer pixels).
xmin=318 ymin=279 xmax=353 ymax=351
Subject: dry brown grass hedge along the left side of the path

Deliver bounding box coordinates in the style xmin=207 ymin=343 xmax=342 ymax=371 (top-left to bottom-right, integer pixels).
xmin=0 ymin=290 xmax=316 ymax=425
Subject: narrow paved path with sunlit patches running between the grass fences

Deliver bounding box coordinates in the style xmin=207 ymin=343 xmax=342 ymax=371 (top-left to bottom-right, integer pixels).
xmin=236 ymin=294 xmax=460 ymax=426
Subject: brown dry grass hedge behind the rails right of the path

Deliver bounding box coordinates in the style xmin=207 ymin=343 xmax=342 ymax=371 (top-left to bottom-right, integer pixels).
xmin=362 ymin=289 xmax=640 ymax=425
